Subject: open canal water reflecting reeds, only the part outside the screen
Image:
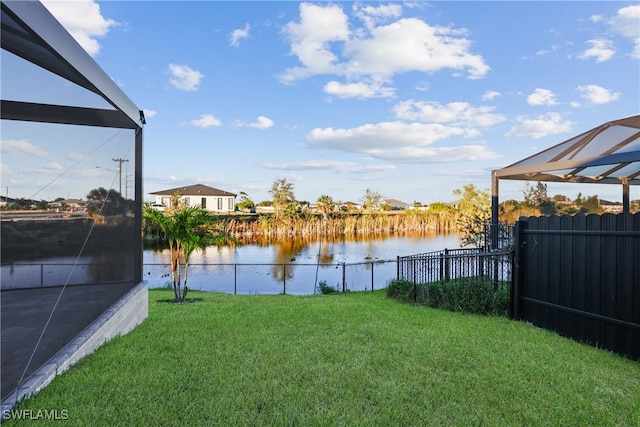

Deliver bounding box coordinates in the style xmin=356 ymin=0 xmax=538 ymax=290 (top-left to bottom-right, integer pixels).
xmin=143 ymin=233 xmax=460 ymax=295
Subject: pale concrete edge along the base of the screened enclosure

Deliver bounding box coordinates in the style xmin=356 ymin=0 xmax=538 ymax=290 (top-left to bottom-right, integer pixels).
xmin=0 ymin=282 xmax=149 ymax=419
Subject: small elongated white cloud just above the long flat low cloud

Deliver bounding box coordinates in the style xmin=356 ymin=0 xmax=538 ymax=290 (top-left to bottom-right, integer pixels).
xmin=393 ymin=100 xmax=506 ymax=127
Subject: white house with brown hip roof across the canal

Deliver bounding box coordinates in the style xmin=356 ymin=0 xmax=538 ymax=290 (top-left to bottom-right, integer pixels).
xmin=149 ymin=184 xmax=237 ymax=212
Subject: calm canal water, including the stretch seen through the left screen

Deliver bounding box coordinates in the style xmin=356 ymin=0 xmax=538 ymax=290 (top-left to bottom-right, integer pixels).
xmin=0 ymin=234 xmax=460 ymax=295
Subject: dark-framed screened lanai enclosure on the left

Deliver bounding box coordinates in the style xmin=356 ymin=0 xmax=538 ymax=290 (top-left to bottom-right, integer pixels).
xmin=0 ymin=1 xmax=144 ymax=400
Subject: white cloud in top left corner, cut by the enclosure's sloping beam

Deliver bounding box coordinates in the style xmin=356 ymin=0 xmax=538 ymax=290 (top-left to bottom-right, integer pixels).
xmin=42 ymin=0 xmax=117 ymax=56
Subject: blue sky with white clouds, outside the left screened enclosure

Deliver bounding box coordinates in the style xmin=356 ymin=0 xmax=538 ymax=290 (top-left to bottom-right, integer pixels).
xmin=8 ymin=0 xmax=640 ymax=203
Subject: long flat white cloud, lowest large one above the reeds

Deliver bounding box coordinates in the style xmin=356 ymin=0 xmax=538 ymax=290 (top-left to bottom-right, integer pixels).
xmin=306 ymin=122 xmax=496 ymax=163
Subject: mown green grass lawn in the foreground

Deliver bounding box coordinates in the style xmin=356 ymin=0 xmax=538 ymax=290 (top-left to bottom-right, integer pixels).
xmin=6 ymin=290 xmax=640 ymax=426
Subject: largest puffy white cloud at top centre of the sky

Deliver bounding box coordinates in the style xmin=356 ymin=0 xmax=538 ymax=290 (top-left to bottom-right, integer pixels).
xmin=281 ymin=3 xmax=489 ymax=88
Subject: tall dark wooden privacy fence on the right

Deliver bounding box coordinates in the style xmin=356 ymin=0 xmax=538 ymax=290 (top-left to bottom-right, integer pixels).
xmin=511 ymin=213 xmax=640 ymax=359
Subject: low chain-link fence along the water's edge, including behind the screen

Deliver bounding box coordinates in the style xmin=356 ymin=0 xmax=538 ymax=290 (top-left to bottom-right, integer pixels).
xmin=1 ymin=260 xmax=396 ymax=295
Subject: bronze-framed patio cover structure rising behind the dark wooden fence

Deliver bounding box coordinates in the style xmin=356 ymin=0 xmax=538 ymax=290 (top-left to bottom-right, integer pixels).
xmin=491 ymin=115 xmax=640 ymax=247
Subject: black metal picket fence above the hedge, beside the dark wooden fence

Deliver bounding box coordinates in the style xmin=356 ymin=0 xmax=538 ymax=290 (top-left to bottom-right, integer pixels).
xmin=396 ymin=248 xmax=511 ymax=283
